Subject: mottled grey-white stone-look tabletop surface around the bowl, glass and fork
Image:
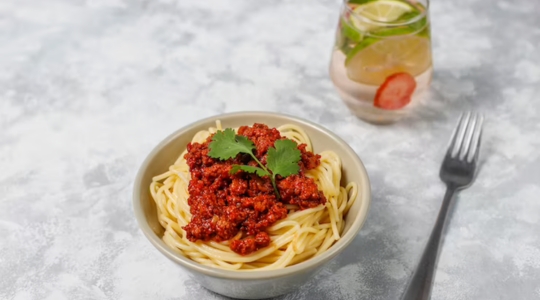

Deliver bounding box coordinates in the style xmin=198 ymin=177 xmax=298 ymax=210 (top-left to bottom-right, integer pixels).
xmin=0 ymin=0 xmax=540 ymax=300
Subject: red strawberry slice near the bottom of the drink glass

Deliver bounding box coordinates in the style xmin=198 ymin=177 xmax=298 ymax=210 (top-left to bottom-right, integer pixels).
xmin=373 ymin=73 xmax=416 ymax=110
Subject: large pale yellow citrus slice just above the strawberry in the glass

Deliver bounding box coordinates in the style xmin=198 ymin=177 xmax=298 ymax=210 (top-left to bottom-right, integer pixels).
xmin=345 ymin=35 xmax=431 ymax=85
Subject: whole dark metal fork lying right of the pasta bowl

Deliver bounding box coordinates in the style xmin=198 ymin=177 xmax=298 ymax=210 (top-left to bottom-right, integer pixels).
xmin=401 ymin=112 xmax=484 ymax=300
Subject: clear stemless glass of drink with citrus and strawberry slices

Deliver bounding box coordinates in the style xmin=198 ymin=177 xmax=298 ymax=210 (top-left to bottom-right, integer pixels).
xmin=330 ymin=0 xmax=433 ymax=123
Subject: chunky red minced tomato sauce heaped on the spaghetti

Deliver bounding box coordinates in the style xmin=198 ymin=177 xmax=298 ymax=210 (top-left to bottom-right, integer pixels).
xmin=183 ymin=124 xmax=326 ymax=255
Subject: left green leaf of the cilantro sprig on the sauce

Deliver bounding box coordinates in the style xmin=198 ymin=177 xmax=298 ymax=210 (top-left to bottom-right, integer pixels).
xmin=208 ymin=128 xmax=255 ymax=160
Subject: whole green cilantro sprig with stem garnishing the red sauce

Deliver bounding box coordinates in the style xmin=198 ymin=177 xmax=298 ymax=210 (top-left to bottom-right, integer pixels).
xmin=208 ymin=128 xmax=302 ymax=198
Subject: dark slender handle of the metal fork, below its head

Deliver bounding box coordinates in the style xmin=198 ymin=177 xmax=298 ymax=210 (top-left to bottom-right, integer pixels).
xmin=401 ymin=185 xmax=456 ymax=300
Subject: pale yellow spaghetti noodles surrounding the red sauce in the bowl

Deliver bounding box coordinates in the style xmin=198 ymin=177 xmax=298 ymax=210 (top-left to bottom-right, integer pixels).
xmin=150 ymin=121 xmax=358 ymax=271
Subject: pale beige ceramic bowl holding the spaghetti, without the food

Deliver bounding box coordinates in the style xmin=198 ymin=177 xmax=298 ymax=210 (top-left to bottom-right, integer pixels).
xmin=133 ymin=112 xmax=371 ymax=299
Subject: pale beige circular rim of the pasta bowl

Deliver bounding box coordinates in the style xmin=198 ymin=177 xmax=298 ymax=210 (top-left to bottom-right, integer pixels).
xmin=132 ymin=111 xmax=371 ymax=280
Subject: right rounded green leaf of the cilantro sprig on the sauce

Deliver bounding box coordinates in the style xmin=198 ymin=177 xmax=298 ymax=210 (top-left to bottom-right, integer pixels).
xmin=266 ymin=140 xmax=302 ymax=177
